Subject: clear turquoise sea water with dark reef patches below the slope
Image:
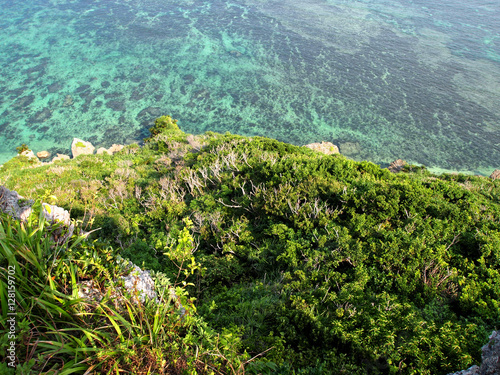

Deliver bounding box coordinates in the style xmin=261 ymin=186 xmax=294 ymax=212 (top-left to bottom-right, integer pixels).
xmin=0 ymin=0 xmax=500 ymax=174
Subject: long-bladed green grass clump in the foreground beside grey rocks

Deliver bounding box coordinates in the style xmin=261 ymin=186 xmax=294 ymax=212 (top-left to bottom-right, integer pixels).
xmin=0 ymin=201 xmax=254 ymax=374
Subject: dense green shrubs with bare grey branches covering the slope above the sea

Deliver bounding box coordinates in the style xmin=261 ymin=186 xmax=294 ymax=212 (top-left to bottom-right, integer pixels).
xmin=0 ymin=117 xmax=500 ymax=374
